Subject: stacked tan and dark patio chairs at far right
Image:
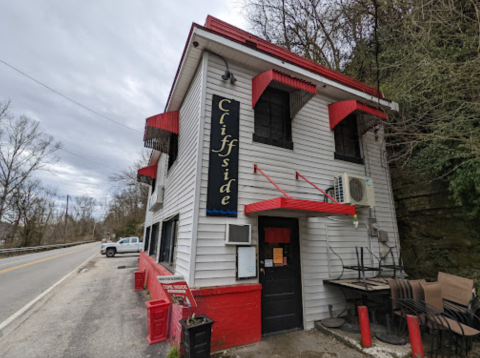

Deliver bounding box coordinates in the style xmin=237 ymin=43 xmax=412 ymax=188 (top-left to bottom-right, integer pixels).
xmin=387 ymin=273 xmax=480 ymax=357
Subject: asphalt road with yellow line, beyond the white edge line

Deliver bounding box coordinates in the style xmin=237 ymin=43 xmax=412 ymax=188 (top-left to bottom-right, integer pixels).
xmin=0 ymin=242 xmax=101 ymax=324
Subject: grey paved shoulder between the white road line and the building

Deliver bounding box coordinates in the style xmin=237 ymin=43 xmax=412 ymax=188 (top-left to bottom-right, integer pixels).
xmin=0 ymin=254 xmax=171 ymax=358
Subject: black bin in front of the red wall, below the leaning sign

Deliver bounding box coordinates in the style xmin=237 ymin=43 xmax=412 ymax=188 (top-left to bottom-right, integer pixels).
xmin=180 ymin=316 xmax=215 ymax=358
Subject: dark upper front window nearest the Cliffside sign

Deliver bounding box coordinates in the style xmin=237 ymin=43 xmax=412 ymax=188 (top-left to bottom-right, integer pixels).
xmin=253 ymin=87 xmax=293 ymax=149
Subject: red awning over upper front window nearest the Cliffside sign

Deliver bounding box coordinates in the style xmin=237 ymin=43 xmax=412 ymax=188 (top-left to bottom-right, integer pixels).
xmin=252 ymin=70 xmax=317 ymax=118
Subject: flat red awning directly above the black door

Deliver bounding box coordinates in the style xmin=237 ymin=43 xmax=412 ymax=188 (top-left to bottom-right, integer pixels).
xmin=245 ymin=197 xmax=355 ymax=216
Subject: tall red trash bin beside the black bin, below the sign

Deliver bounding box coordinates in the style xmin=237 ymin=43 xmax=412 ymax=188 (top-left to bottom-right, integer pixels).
xmin=145 ymin=300 xmax=170 ymax=344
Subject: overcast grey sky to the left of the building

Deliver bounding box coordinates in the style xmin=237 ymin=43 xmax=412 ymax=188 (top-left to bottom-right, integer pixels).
xmin=0 ymin=0 xmax=246 ymax=204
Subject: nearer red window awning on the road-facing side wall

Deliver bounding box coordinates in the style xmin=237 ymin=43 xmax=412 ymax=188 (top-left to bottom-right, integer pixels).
xmin=143 ymin=111 xmax=179 ymax=153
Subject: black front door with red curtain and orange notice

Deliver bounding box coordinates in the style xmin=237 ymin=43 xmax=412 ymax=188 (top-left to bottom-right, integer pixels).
xmin=258 ymin=217 xmax=303 ymax=334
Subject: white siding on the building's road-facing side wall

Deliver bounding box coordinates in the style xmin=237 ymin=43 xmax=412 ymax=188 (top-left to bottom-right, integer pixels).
xmin=145 ymin=59 xmax=203 ymax=280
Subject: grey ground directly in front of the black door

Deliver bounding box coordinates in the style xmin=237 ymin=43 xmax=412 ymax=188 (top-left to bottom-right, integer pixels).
xmin=215 ymin=330 xmax=366 ymax=358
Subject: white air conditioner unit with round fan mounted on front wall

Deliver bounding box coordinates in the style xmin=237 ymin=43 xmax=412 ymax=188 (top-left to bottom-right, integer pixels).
xmin=333 ymin=173 xmax=375 ymax=208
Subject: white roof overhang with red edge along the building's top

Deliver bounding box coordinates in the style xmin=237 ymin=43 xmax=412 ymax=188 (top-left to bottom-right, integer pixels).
xmin=165 ymin=19 xmax=398 ymax=111
